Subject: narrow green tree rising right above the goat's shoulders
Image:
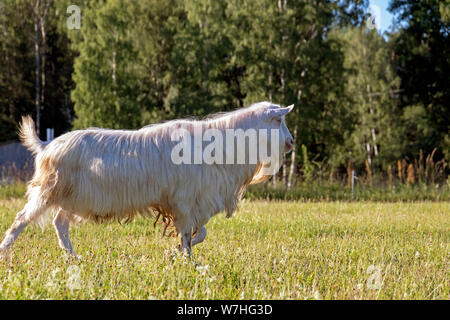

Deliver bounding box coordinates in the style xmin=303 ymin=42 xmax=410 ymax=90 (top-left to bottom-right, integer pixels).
xmin=165 ymin=0 xmax=244 ymax=116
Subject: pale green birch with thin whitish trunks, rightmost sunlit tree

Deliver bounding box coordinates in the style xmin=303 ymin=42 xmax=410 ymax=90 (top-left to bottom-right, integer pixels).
xmin=330 ymin=26 xmax=403 ymax=167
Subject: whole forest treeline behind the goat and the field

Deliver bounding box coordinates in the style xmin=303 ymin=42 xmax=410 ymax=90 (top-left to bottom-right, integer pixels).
xmin=0 ymin=0 xmax=450 ymax=180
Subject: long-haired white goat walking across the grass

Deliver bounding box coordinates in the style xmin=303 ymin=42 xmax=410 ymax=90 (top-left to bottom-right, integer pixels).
xmin=0 ymin=102 xmax=293 ymax=256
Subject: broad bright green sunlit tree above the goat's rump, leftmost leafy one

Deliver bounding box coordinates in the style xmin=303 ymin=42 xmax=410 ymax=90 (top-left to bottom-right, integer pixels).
xmin=71 ymin=0 xmax=182 ymax=128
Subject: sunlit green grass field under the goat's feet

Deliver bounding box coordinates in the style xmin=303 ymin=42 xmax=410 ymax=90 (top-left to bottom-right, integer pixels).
xmin=0 ymin=198 xmax=450 ymax=299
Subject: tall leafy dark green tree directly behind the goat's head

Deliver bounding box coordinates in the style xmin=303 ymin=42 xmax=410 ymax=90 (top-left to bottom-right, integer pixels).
xmin=223 ymin=0 xmax=364 ymax=182
